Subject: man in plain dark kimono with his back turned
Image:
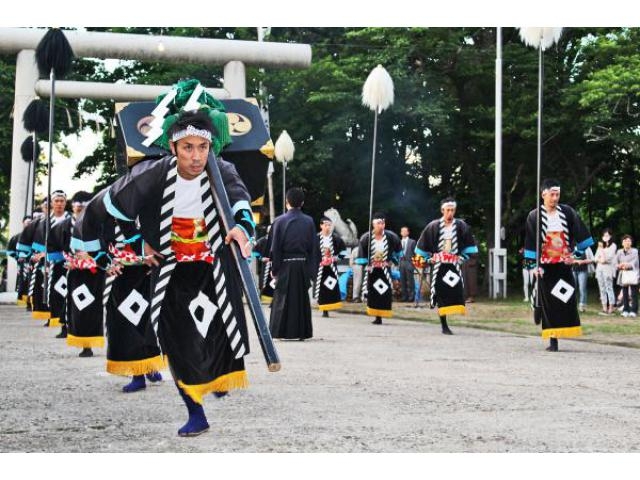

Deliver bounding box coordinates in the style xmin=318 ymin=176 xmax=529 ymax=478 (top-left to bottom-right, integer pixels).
xmin=269 ymin=187 xmax=320 ymax=341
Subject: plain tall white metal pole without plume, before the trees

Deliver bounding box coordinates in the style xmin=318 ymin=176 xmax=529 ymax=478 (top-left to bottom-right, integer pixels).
xmin=493 ymin=27 xmax=502 ymax=299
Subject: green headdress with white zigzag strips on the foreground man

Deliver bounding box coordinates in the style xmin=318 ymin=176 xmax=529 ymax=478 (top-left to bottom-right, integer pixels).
xmin=153 ymin=79 xmax=232 ymax=155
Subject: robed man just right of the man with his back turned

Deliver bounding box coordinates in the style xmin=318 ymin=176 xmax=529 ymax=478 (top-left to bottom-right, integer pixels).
xmin=313 ymin=217 xmax=347 ymax=317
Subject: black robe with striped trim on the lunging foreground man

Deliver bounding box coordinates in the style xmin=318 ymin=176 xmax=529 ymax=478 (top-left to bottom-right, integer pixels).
xmin=92 ymin=156 xmax=254 ymax=403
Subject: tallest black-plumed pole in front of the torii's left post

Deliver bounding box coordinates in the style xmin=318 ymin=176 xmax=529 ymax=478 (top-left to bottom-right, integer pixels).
xmin=36 ymin=28 xmax=74 ymax=304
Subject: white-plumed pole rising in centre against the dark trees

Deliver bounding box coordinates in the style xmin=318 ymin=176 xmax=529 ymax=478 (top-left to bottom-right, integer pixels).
xmin=362 ymin=65 xmax=394 ymax=261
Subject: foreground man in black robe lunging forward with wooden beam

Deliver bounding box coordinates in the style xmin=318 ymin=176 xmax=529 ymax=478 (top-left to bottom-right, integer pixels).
xmin=95 ymin=108 xmax=255 ymax=436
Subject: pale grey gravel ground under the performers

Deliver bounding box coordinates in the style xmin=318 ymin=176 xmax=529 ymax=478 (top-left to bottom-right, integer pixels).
xmin=0 ymin=305 xmax=640 ymax=452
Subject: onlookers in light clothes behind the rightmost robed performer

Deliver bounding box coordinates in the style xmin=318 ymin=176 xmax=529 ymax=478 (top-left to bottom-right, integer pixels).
xmin=522 ymin=228 xmax=640 ymax=317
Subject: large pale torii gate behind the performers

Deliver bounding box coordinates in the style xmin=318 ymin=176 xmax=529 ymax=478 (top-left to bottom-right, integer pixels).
xmin=0 ymin=28 xmax=311 ymax=291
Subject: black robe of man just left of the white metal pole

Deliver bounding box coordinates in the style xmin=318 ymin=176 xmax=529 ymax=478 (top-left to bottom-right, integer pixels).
xmin=415 ymin=218 xmax=478 ymax=316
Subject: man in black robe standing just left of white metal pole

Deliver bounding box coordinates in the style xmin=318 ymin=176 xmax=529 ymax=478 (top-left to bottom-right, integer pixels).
xmin=416 ymin=197 xmax=478 ymax=335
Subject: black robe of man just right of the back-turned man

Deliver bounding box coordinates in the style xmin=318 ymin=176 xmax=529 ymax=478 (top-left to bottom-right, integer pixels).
xmin=313 ymin=232 xmax=347 ymax=311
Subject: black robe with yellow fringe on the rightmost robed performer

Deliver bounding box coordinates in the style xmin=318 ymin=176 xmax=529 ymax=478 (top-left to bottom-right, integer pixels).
xmin=524 ymin=204 xmax=594 ymax=338
